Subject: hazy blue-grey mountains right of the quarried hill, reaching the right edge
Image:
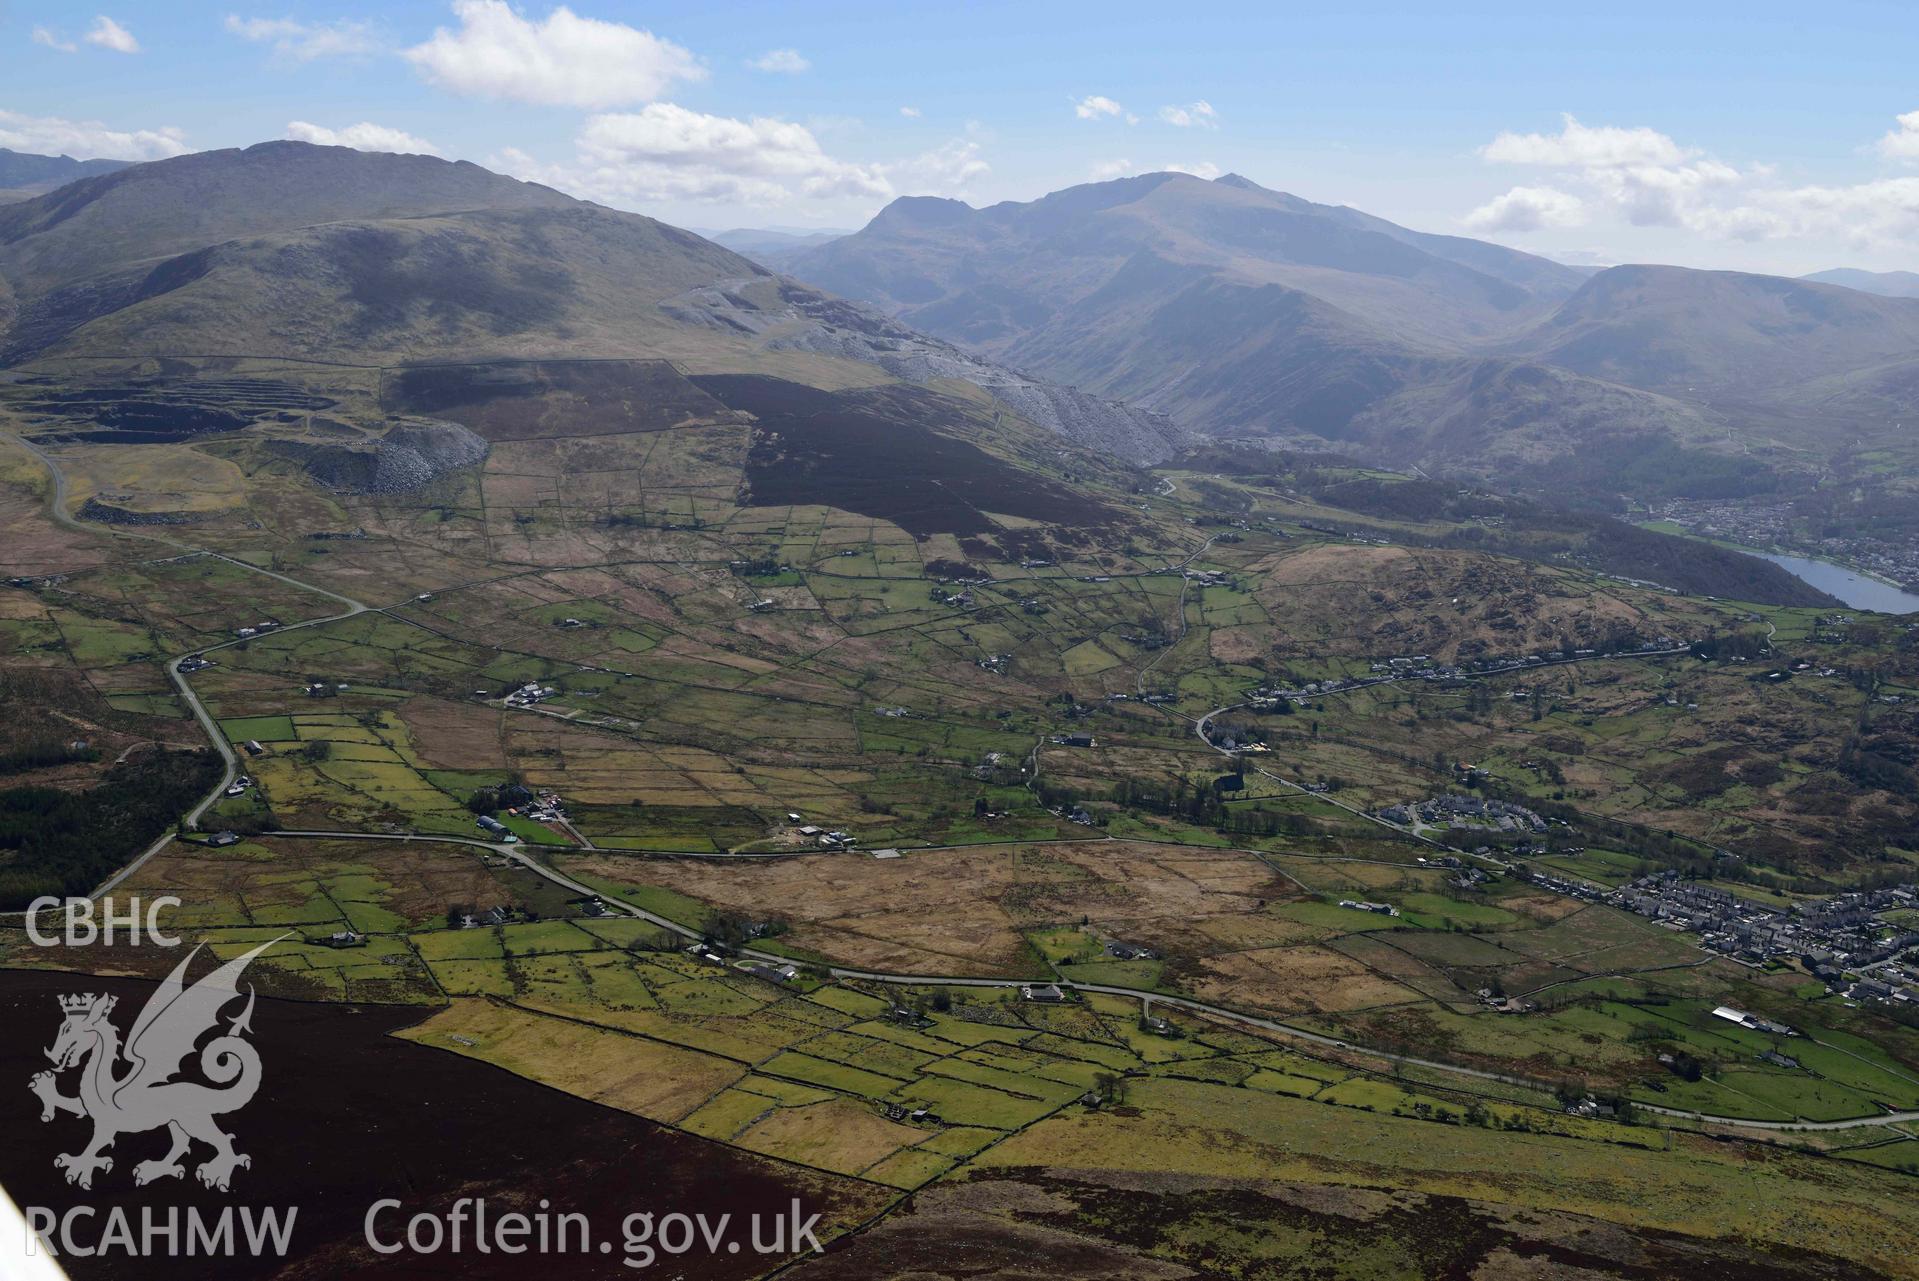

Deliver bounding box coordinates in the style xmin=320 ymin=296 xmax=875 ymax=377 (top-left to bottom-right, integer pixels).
xmin=787 ymin=173 xmax=1919 ymax=493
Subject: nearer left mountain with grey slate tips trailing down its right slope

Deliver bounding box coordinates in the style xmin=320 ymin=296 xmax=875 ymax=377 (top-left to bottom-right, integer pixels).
xmin=0 ymin=142 xmax=1184 ymax=460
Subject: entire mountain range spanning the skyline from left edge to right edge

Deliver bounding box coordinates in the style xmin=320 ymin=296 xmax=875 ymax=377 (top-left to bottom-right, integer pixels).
xmin=14 ymin=142 xmax=1919 ymax=497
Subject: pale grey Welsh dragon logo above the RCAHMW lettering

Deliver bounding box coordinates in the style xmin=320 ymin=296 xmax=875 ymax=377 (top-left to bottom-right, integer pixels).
xmin=31 ymin=940 xmax=280 ymax=1193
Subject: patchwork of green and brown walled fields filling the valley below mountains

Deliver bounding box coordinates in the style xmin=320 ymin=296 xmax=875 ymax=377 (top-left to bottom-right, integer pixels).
xmin=0 ymin=364 xmax=1919 ymax=1279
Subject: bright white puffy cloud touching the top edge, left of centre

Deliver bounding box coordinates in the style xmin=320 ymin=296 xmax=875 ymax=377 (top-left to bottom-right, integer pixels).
xmin=405 ymin=0 xmax=706 ymax=109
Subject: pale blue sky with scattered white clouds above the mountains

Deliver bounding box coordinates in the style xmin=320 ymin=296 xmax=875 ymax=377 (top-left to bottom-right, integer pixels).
xmin=0 ymin=0 xmax=1919 ymax=274
